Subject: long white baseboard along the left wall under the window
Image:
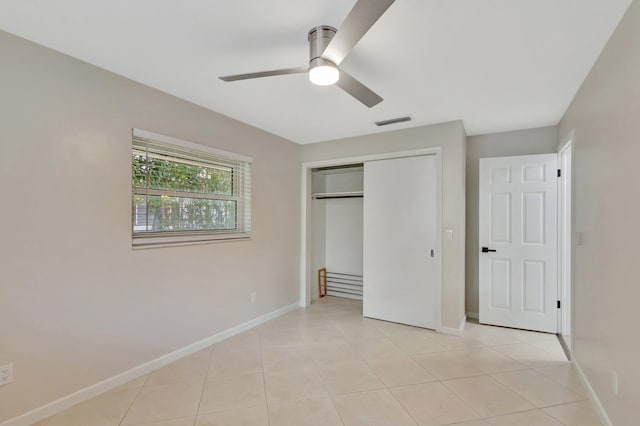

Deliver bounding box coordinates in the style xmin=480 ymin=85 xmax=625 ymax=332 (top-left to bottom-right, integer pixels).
xmin=0 ymin=302 xmax=300 ymax=426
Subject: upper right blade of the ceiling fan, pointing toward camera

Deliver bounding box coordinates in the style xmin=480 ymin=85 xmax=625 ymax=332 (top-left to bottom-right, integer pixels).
xmin=322 ymin=0 xmax=395 ymax=65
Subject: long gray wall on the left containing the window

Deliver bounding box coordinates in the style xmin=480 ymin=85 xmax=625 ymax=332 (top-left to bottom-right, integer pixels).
xmin=0 ymin=32 xmax=301 ymax=422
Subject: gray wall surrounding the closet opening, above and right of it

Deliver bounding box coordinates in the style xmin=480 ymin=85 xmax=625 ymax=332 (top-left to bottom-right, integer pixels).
xmin=302 ymin=121 xmax=466 ymax=328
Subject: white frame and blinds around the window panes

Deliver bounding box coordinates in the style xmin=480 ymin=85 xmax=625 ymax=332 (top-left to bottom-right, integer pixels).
xmin=129 ymin=128 xmax=253 ymax=249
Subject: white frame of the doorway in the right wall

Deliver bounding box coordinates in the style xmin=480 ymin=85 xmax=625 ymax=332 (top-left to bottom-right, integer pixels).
xmin=558 ymin=130 xmax=575 ymax=359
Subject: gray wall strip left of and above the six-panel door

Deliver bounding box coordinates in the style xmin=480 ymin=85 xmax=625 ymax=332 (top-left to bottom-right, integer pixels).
xmin=466 ymin=126 xmax=558 ymax=316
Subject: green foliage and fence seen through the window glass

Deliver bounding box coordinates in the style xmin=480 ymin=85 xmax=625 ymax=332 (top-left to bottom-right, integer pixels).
xmin=131 ymin=138 xmax=250 ymax=236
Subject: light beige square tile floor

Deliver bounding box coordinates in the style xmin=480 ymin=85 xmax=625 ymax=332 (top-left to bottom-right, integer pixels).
xmin=37 ymin=297 xmax=601 ymax=426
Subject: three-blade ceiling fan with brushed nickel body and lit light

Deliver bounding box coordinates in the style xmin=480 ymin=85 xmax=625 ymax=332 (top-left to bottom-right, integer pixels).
xmin=220 ymin=0 xmax=395 ymax=108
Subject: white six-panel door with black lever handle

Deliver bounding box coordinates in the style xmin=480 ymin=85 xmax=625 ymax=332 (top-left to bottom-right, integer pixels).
xmin=478 ymin=154 xmax=558 ymax=333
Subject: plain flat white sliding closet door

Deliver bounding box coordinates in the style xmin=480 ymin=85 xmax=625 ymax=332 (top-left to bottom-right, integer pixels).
xmin=363 ymin=155 xmax=440 ymax=328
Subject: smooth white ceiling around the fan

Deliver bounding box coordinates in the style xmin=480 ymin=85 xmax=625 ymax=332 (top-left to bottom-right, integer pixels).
xmin=0 ymin=0 xmax=631 ymax=143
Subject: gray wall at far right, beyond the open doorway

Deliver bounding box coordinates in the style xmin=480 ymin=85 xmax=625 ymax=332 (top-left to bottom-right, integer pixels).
xmin=559 ymin=1 xmax=640 ymax=426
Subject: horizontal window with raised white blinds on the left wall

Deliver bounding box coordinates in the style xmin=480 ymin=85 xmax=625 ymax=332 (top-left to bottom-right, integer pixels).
xmin=131 ymin=129 xmax=251 ymax=246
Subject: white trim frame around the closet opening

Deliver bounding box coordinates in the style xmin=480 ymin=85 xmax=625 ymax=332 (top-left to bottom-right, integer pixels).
xmin=299 ymin=147 xmax=443 ymax=332
